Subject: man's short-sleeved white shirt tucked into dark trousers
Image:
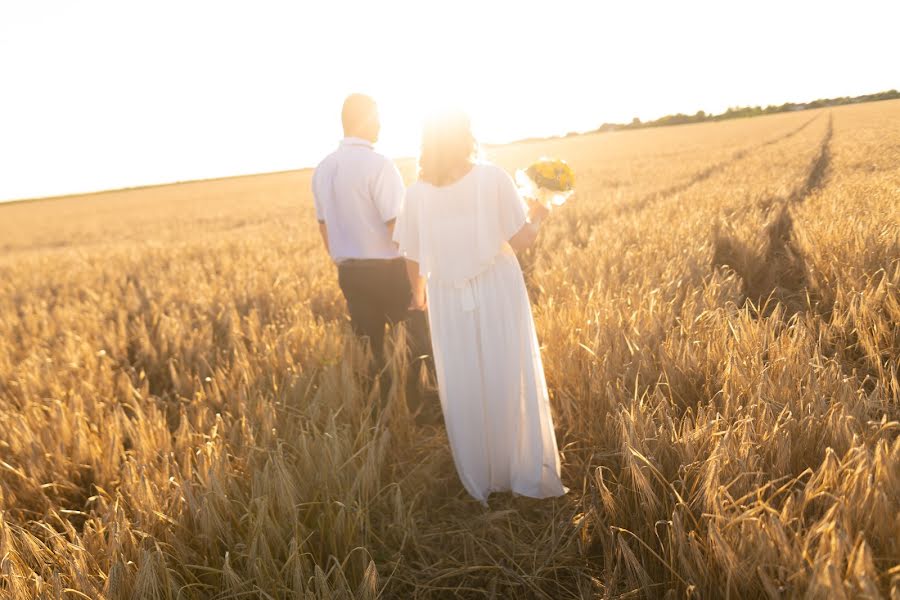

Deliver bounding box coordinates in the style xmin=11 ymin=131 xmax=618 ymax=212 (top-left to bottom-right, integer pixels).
xmin=312 ymin=137 xmax=405 ymax=262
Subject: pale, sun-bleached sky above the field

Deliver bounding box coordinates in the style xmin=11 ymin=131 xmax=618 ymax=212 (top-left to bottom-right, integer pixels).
xmin=0 ymin=0 xmax=900 ymax=200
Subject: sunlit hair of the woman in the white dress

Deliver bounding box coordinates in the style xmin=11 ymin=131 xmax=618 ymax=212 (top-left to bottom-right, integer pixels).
xmin=419 ymin=110 xmax=479 ymax=185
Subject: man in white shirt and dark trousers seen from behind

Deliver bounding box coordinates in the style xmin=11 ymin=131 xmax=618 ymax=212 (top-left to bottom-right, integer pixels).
xmin=312 ymin=94 xmax=431 ymax=412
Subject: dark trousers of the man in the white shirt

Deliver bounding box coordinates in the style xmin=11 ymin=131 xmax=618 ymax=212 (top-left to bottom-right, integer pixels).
xmin=338 ymin=258 xmax=434 ymax=412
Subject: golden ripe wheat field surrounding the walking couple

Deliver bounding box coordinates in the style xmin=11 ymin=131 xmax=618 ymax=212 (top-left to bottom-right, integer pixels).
xmin=0 ymin=101 xmax=900 ymax=600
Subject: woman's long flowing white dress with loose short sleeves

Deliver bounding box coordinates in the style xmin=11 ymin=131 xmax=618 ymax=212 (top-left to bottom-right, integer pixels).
xmin=394 ymin=163 xmax=568 ymax=506
